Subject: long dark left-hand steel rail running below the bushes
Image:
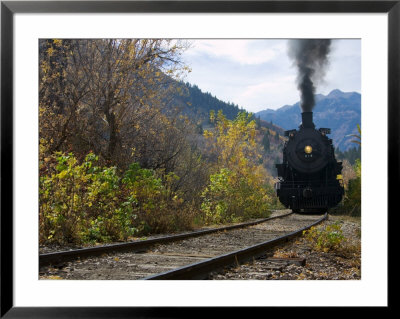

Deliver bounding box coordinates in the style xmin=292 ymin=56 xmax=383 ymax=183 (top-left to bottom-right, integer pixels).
xmin=39 ymin=212 xmax=293 ymax=267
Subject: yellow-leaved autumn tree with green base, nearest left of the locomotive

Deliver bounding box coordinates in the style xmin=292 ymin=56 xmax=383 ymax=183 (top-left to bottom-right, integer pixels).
xmin=202 ymin=112 xmax=272 ymax=222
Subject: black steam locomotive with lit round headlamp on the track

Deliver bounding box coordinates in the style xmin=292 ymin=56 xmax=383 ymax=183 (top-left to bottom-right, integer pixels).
xmin=275 ymin=112 xmax=344 ymax=213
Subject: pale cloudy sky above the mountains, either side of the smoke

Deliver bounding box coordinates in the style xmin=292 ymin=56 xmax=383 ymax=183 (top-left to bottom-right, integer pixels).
xmin=182 ymin=39 xmax=361 ymax=113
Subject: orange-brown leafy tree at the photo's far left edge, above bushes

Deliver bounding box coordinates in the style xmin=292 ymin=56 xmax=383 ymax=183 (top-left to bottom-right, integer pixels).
xmin=39 ymin=40 xmax=90 ymax=157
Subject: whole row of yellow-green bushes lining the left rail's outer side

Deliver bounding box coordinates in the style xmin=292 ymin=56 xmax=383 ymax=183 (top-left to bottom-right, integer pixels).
xmin=39 ymin=153 xmax=195 ymax=244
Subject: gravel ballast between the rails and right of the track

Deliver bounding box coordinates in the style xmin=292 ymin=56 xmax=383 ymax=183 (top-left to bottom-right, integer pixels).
xmin=39 ymin=211 xmax=361 ymax=280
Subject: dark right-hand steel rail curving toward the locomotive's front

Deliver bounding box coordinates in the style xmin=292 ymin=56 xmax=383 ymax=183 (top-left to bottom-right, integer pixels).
xmin=142 ymin=213 xmax=328 ymax=280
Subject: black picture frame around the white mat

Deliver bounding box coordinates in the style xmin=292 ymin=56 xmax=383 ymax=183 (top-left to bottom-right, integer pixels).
xmin=0 ymin=0 xmax=394 ymax=318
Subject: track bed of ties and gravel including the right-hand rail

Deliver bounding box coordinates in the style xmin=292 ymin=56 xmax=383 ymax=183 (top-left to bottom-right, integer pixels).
xmin=39 ymin=214 xmax=327 ymax=280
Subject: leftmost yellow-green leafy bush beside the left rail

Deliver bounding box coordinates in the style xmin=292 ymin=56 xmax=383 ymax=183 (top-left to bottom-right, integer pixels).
xmin=39 ymin=153 xmax=137 ymax=243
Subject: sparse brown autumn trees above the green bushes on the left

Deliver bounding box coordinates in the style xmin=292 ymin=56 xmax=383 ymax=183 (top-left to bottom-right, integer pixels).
xmin=39 ymin=39 xmax=208 ymax=215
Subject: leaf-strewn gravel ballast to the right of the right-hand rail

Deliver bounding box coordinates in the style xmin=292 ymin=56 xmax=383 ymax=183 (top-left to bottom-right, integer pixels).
xmin=209 ymin=216 xmax=361 ymax=280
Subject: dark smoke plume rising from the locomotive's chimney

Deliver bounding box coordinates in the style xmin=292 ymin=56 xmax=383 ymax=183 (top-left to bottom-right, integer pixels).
xmin=288 ymin=39 xmax=331 ymax=112
